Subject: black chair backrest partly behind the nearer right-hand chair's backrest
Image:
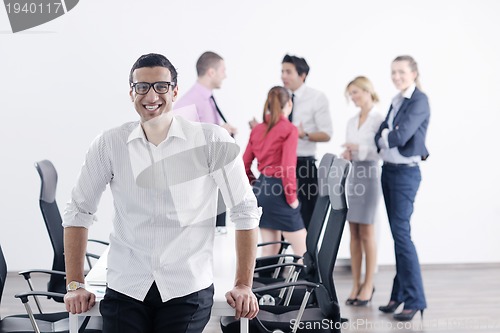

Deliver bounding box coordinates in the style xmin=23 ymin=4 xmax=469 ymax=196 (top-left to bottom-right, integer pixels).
xmin=304 ymin=153 xmax=335 ymax=281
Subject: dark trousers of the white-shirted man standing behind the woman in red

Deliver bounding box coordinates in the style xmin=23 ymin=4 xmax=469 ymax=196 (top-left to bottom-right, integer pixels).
xmin=297 ymin=156 xmax=319 ymax=230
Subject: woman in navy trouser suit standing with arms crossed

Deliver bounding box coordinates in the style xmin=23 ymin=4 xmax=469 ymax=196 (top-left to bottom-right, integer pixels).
xmin=375 ymin=55 xmax=430 ymax=321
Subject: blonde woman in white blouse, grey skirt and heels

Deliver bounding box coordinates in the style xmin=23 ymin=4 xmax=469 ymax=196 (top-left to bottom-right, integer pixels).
xmin=342 ymin=76 xmax=384 ymax=306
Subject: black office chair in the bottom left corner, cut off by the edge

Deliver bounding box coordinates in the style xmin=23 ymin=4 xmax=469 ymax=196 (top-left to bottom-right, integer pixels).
xmin=0 ymin=246 xmax=102 ymax=333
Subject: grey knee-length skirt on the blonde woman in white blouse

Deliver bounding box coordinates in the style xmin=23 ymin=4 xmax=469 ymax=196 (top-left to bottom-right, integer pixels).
xmin=347 ymin=161 xmax=381 ymax=224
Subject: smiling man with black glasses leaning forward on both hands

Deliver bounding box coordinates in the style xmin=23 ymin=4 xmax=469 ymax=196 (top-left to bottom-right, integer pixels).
xmin=63 ymin=54 xmax=260 ymax=333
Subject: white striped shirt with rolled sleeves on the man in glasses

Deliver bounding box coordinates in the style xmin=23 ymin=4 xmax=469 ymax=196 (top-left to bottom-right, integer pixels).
xmin=63 ymin=116 xmax=261 ymax=302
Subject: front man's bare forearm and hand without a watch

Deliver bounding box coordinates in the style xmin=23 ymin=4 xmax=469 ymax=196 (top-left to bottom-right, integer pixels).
xmin=226 ymin=228 xmax=259 ymax=319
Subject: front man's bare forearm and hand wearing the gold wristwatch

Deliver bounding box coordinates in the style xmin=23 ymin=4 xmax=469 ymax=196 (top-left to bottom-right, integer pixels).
xmin=64 ymin=227 xmax=95 ymax=314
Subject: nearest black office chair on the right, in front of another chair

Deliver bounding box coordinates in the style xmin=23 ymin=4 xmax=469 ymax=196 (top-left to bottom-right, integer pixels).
xmin=220 ymin=158 xmax=350 ymax=333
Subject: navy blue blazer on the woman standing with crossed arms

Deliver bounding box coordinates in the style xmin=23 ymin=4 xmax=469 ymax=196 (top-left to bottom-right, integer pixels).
xmin=375 ymin=88 xmax=431 ymax=160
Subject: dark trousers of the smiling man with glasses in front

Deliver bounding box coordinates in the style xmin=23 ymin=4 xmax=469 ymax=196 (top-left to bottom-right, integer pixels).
xmin=100 ymin=283 xmax=214 ymax=333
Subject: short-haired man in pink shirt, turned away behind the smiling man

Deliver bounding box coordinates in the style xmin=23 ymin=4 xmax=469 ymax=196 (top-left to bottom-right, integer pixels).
xmin=174 ymin=51 xmax=237 ymax=234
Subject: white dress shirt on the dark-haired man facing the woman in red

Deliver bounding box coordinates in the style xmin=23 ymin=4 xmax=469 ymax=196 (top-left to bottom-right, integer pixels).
xmin=292 ymin=84 xmax=333 ymax=156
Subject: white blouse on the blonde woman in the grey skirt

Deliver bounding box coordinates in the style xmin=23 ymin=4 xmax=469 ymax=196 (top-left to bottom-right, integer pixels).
xmin=346 ymin=107 xmax=384 ymax=161
